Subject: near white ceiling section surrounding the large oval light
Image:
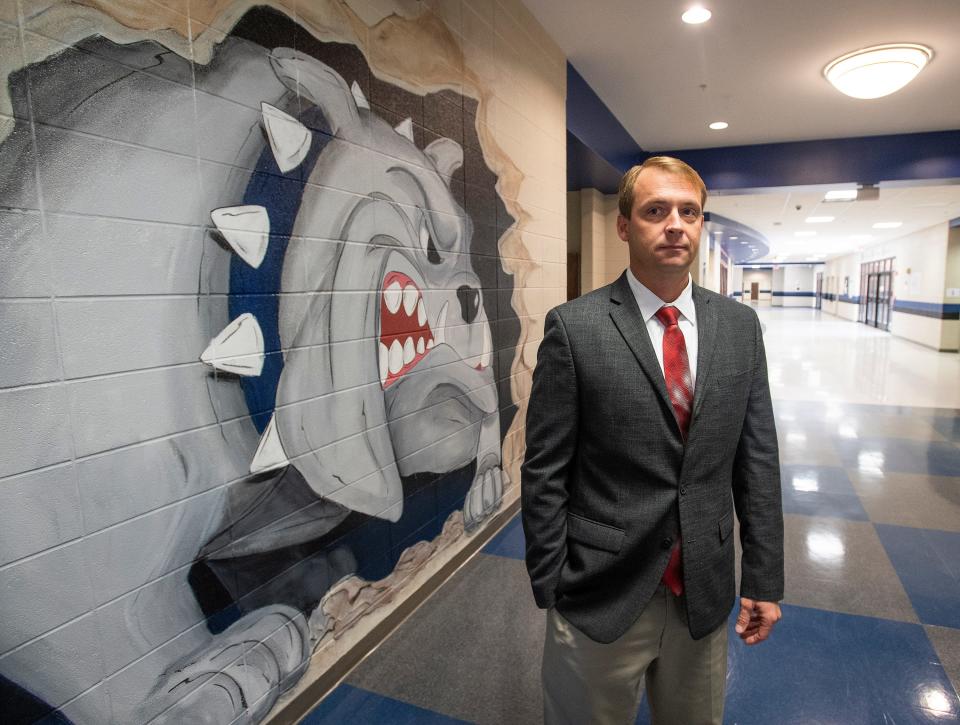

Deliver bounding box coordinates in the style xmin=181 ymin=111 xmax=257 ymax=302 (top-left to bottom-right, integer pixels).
xmin=524 ymin=0 xmax=960 ymax=151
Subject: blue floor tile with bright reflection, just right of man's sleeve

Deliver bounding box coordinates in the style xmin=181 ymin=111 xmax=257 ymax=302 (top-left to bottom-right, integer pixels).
xmin=780 ymin=465 xmax=868 ymax=521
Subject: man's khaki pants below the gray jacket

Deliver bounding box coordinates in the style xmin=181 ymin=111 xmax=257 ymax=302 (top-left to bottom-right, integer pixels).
xmin=543 ymin=585 xmax=727 ymax=725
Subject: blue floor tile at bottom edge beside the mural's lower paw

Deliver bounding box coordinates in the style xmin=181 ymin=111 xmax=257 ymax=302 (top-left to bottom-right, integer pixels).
xmin=300 ymin=685 xmax=465 ymax=725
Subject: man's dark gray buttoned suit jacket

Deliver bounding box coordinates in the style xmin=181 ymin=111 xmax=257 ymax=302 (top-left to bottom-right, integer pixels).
xmin=521 ymin=273 xmax=783 ymax=642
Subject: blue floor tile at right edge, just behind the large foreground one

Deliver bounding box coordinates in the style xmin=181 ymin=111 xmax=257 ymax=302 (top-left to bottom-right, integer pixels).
xmin=875 ymin=524 xmax=960 ymax=628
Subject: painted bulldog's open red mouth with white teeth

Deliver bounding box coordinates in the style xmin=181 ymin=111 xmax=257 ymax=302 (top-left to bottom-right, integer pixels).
xmin=378 ymin=272 xmax=436 ymax=390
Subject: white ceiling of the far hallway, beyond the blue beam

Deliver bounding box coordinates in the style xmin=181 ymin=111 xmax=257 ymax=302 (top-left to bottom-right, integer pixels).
xmin=706 ymin=184 xmax=960 ymax=262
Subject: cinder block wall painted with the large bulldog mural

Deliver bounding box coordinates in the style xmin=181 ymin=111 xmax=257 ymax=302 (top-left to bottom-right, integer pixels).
xmin=0 ymin=0 xmax=566 ymax=725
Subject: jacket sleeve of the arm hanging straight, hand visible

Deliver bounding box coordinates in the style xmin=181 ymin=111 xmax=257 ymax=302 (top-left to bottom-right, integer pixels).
xmin=733 ymin=318 xmax=783 ymax=602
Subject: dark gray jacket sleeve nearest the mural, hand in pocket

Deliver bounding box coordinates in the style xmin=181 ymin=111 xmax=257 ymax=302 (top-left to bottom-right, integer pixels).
xmin=520 ymin=309 xmax=580 ymax=609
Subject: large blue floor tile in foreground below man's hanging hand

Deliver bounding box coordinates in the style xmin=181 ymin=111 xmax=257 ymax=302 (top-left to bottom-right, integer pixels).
xmin=636 ymin=605 xmax=960 ymax=725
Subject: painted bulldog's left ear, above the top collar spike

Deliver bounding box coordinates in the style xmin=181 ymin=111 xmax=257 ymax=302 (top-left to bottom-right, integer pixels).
xmin=270 ymin=48 xmax=362 ymax=133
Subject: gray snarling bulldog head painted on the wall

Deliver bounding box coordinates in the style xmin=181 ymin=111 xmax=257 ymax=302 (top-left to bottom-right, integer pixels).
xmin=251 ymin=49 xmax=499 ymax=521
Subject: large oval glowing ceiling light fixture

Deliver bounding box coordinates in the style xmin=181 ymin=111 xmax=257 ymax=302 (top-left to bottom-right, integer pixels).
xmin=823 ymin=43 xmax=933 ymax=99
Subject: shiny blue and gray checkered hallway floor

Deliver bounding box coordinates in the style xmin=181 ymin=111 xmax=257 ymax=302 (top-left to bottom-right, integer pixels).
xmin=303 ymin=308 xmax=960 ymax=725
